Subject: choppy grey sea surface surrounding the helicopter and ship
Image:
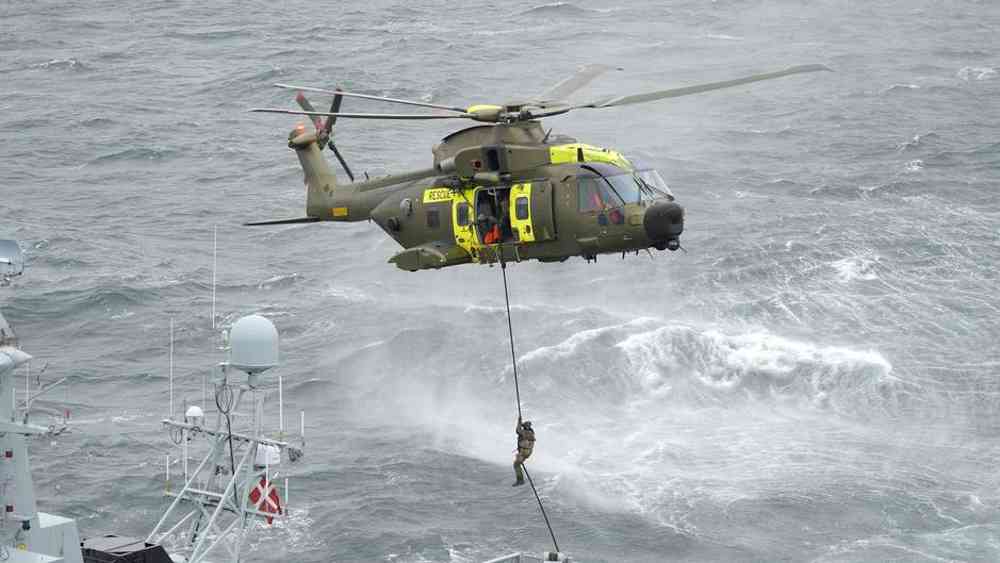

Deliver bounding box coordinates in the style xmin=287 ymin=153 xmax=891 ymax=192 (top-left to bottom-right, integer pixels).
xmin=0 ymin=0 xmax=1000 ymax=562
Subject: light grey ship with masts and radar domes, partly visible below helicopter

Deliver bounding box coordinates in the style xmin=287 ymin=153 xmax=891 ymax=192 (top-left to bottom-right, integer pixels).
xmin=0 ymin=240 xmax=575 ymax=563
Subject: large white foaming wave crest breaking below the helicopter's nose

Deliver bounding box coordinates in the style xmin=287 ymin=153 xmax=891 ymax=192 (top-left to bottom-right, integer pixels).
xmin=519 ymin=322 xmax=904 ymax=412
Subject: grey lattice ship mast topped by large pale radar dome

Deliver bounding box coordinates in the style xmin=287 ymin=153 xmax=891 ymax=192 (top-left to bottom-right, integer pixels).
xmin=146 ymin=237 xmax=305 ymax=563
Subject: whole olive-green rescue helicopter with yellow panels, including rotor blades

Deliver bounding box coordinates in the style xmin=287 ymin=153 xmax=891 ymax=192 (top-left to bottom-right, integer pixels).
xmin=246 ymin=64 xmax=830 ymax=271
